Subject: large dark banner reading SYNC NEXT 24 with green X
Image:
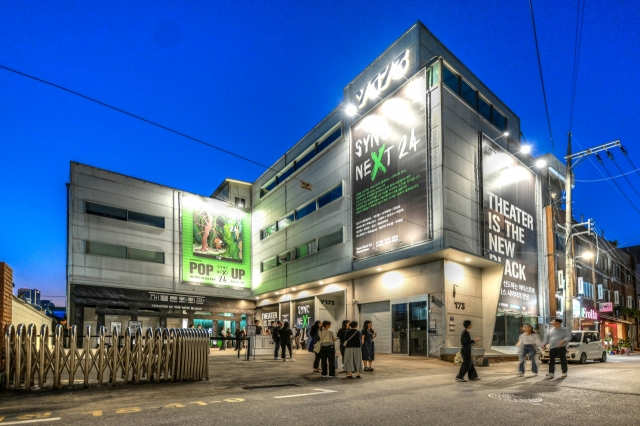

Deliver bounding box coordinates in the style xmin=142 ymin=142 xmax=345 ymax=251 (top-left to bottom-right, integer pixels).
xmin=350 ymin=70 xmax=430 ymax=259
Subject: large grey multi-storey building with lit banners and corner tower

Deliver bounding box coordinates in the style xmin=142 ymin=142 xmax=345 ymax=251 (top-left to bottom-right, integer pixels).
xmin=68 ymin=22 xmax=550 ymax=356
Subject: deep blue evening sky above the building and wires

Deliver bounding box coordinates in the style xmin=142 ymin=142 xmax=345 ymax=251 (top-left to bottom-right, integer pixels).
xmin=0 ymin=0 xmax=640 ymax=305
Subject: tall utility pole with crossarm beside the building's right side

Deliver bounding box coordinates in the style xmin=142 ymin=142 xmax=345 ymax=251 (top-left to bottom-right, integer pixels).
xmin=564 ymin=137 xmax=621 ymax=330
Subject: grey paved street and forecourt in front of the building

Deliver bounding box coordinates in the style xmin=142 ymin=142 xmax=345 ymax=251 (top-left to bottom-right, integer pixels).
xmin=0 ymin=352 xmax=640 ymax=426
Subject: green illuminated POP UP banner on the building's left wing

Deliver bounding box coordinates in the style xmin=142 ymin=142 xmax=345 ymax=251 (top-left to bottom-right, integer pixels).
xmin=180 ymin=194 xmax=251 ymax=288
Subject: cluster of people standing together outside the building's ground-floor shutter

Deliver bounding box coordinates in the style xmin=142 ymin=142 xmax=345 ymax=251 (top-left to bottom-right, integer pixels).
xmin=309 ymin=320 xmax=378 ymax=379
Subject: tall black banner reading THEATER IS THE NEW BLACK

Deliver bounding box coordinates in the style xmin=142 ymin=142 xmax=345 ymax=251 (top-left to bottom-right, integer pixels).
xmin=482 ymin=136 xmax=538 ymax=315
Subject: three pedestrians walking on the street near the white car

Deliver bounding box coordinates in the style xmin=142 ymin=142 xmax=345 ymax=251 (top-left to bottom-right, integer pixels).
xmin=456 ymin=318 xmax=571 ymax=382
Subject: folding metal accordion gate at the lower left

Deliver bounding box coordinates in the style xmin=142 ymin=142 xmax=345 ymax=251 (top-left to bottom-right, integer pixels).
xmin=2 ymin=324 xmax=209 ymax=390
